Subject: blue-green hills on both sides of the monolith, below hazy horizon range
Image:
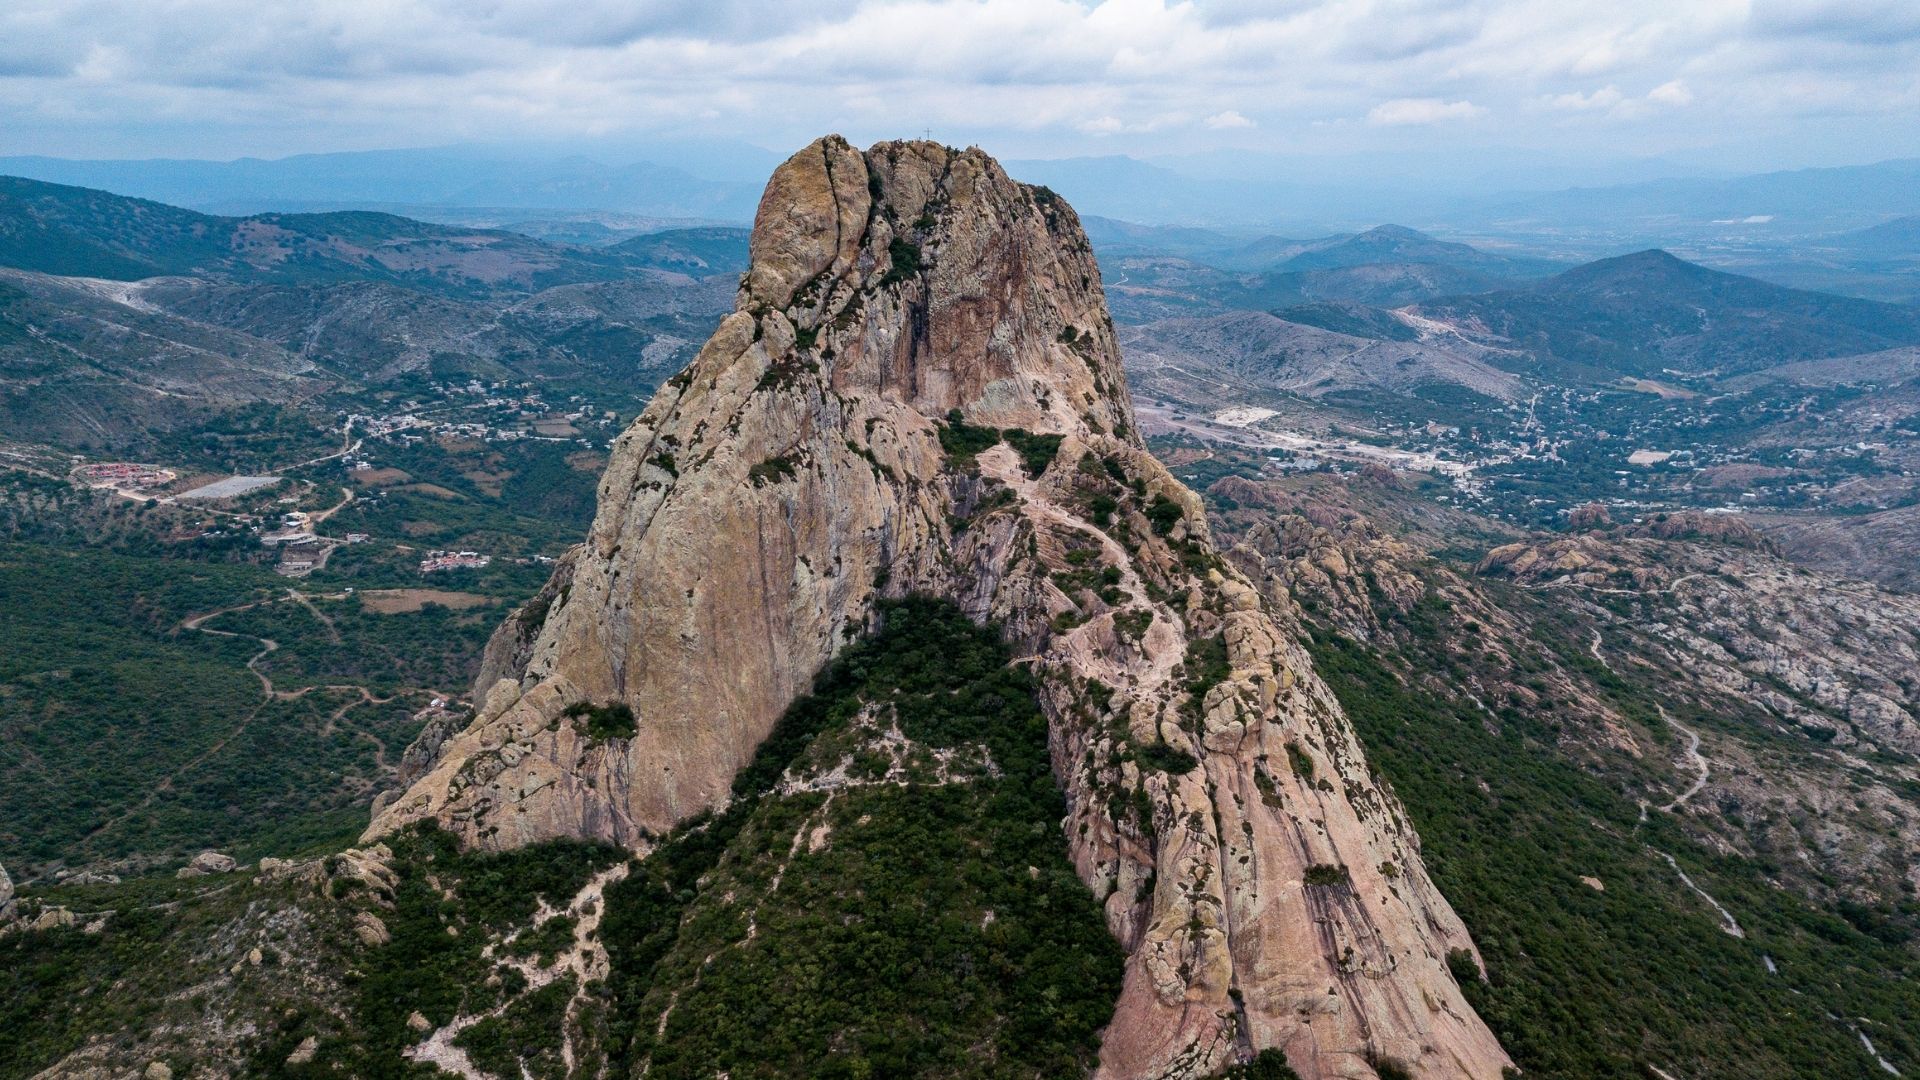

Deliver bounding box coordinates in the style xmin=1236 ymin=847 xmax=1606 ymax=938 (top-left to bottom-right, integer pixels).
xmin=0 ymin=166 xmax=1920 ymax=451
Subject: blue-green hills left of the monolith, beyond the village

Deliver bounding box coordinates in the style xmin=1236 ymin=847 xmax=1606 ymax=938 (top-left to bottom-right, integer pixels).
xmin=0 ymin=177 xmax=747 ymax=450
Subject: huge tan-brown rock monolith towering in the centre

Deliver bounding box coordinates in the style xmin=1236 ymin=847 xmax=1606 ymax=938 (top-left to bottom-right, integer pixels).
xmin=369 ymin=138 xmax=1507 ymax=1080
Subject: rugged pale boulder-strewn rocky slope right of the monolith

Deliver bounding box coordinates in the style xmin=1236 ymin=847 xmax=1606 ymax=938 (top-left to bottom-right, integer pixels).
xmin=1210 ymin=466 xmax=1920 ymax=922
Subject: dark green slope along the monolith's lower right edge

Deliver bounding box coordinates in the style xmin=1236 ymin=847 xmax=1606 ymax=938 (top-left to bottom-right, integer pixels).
xmin=1296 ymin=625 xmax=1920 ymax=1080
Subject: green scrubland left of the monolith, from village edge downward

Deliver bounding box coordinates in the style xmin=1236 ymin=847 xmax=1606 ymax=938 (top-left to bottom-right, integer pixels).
xmin=0 ymin=424 xmax=597 ymax=876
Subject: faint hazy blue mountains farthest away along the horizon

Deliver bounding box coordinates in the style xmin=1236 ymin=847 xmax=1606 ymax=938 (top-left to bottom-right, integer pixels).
xmin=0 ymin=144 xmax=1920 ymax=244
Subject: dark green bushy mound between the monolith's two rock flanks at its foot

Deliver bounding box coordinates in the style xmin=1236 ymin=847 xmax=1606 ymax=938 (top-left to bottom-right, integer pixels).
xmin=603 ymin=600 xmax=1119 ymax=1078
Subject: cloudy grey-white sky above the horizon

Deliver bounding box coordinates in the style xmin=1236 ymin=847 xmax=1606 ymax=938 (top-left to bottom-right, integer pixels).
xmin=0 ymin=0 xmax=1920 ymax=169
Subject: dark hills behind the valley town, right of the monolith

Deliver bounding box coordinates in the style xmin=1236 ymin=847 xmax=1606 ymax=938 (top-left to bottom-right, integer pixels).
xmin=1108 ymin=242 xmax=1920 ymax=423
